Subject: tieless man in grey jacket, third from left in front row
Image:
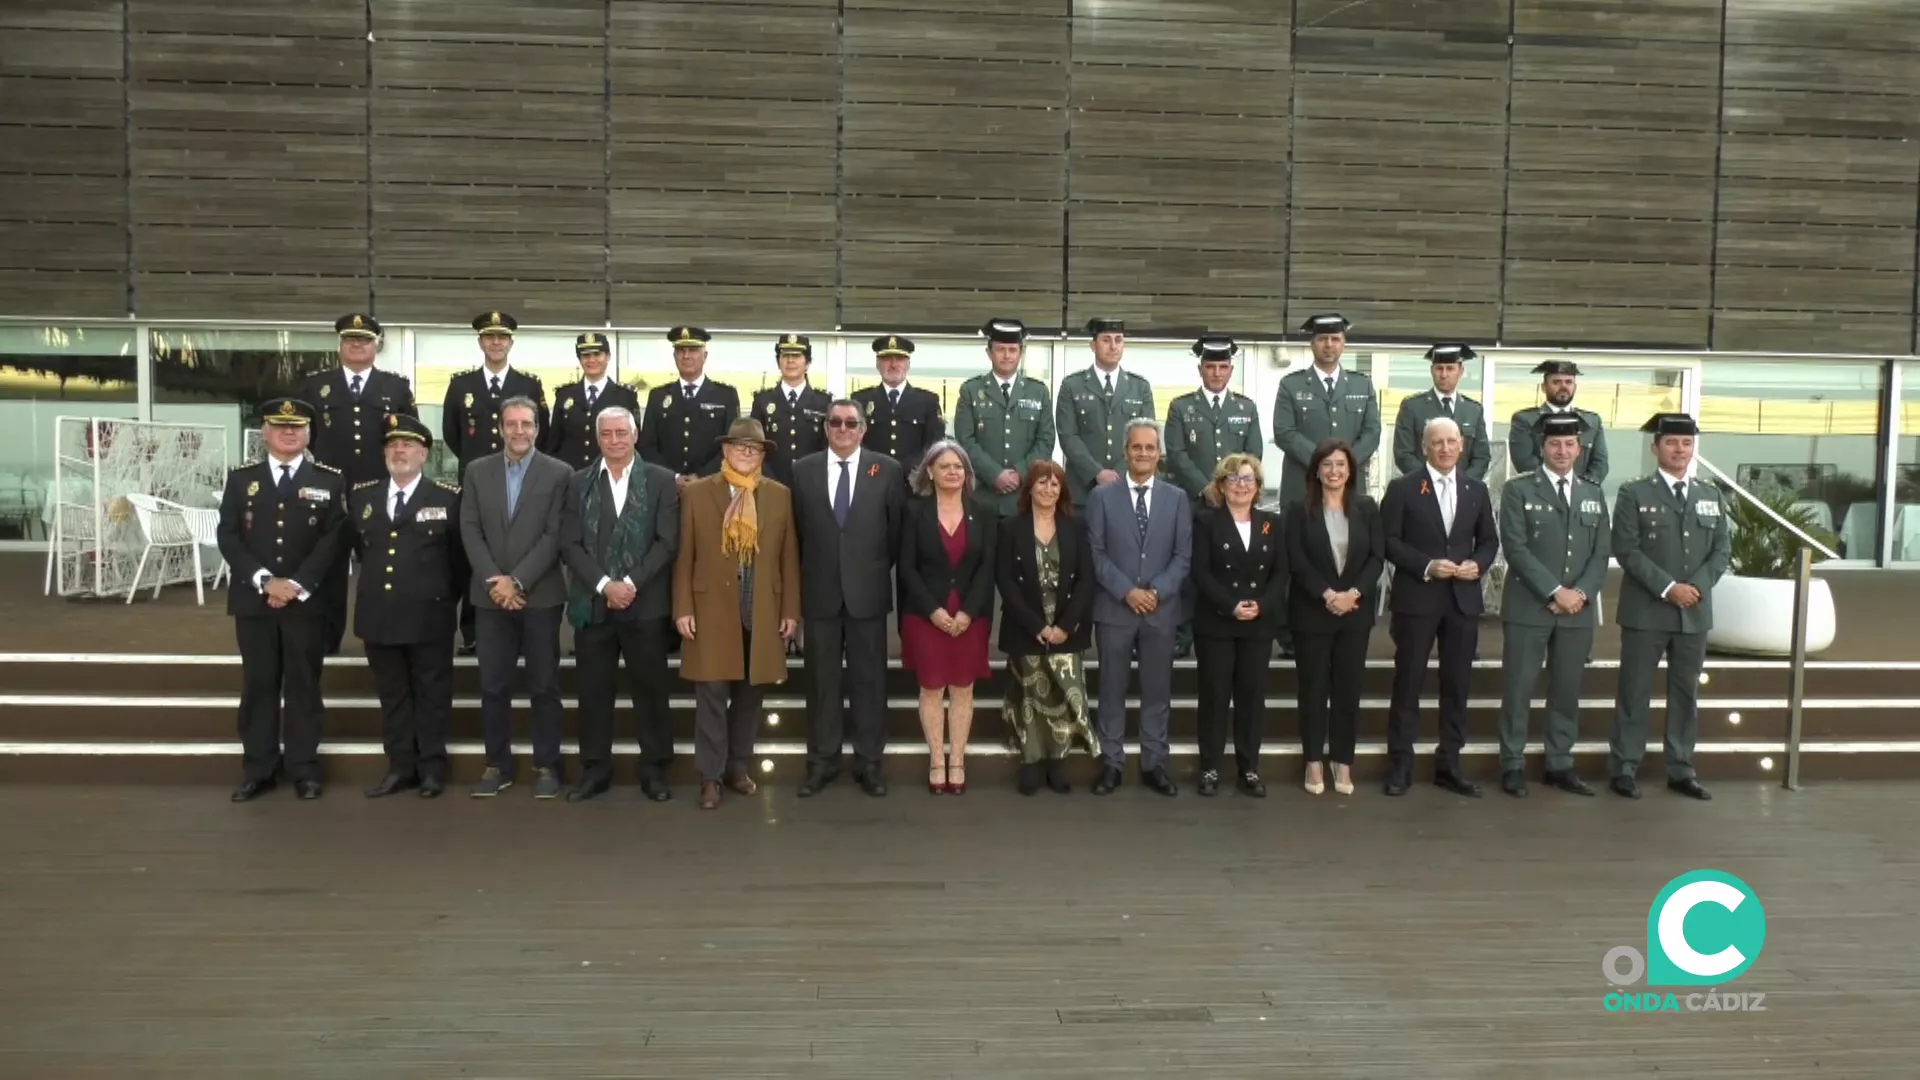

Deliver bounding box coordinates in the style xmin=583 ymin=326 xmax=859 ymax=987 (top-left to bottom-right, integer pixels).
xmin=461 ymin=390 xmax=574 ymax=799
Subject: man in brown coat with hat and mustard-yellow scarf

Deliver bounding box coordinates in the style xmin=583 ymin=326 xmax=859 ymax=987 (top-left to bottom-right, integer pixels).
xmin=674 ymin=419 xmax=801 ymax=809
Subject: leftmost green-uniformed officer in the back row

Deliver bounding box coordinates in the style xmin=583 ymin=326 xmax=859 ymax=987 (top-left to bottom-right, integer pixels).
xmin=952 ymin=319 xmax=1054 ymax=517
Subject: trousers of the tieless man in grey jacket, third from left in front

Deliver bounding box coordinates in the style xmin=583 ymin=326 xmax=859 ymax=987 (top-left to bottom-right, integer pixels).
xmin=474 ymin=605 xmax=564 ymax=778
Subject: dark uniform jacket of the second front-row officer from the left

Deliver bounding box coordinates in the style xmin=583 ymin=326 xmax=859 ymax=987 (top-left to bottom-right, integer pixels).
xmin=348 ymin=477 xmax=467 ymax=638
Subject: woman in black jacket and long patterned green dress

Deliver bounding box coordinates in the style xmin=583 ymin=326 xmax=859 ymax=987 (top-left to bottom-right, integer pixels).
xmin=995 ymin=461 xmax=1100 ymax=796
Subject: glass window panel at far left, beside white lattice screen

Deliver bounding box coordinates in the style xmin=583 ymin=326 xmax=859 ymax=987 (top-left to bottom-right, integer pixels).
xmin=0 ymin=325 xmax=140 ymax=540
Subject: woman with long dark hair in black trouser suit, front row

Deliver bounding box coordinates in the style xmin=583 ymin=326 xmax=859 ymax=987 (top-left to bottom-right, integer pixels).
xmin=1286 ymin=438 xmax=1386 ymax=796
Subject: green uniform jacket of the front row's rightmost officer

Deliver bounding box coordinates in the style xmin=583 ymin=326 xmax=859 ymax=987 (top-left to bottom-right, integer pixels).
xmin=1613 ymin=473 xmax=1734 ymax=634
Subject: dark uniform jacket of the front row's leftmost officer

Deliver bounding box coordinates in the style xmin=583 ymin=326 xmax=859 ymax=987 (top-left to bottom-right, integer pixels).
xmin=217 ymin=457 xmax=348 ymax=619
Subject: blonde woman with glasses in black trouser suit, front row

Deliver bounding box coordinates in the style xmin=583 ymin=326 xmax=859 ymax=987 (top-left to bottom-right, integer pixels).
xmin=1192 ymin=454 xmax=1286 ymax=796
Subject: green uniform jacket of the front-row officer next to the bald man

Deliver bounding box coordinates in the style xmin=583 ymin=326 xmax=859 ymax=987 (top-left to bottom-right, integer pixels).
xmin=1500 ymin=471 xmax=1613 ymax=626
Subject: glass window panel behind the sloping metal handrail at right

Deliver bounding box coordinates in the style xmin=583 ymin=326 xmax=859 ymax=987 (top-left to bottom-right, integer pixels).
xmin=1699 ymin=357 xmax=1882 ymax=559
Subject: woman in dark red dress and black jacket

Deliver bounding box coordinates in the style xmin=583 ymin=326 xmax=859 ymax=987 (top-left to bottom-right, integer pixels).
xmin=897 ymin=440 xmax=993 ymax=796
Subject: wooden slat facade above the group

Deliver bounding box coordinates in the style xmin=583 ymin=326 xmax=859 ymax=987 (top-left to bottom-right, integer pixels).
xmin=0 ymin=0 xmax=1920 ymax=354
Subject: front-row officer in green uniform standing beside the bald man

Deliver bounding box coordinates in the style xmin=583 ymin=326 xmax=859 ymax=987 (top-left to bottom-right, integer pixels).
xmin=1500 ymin=415 xmax=1613 ymax=796
